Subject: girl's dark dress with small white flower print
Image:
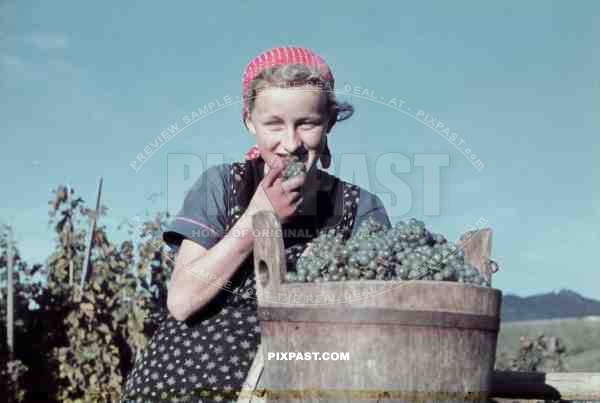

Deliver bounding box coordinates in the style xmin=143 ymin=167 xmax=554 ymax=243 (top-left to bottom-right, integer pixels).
xmin=121 ymin=158 xmax=359 ymax=403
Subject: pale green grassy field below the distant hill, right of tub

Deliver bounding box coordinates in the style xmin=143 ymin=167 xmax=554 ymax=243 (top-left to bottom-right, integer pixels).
xmin=497 ymin=316 xmax=600 ymax=372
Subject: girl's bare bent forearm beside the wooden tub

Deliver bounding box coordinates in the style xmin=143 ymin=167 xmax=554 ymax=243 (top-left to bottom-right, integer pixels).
xmin=169 ymin=212 xmax=254 ymax=320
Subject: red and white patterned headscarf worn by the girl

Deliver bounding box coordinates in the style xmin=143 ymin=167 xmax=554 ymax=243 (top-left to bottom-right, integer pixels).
xmin=242 ymin=47 xmax=334 ymax=160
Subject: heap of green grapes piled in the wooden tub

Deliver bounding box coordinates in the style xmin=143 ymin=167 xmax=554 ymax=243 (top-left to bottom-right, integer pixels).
xmin=287 ymin=217 xmax=490 ymax=286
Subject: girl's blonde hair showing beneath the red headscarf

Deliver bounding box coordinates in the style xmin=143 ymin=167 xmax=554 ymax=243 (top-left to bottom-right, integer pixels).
xmin=244 ymin=64 xmax=354 ymax=131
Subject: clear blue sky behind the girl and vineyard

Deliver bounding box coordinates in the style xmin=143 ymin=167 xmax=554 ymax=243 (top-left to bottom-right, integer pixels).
xmin=0 ymin=0 xmax=600 ymax=298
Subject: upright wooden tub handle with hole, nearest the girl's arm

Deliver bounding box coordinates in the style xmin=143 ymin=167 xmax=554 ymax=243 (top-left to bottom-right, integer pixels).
xmin=252 ymin=211 xmax=287 ymax=305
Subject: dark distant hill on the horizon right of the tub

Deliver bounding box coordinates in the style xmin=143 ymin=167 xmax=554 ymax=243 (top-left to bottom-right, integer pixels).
xmin=501 ymin=290 xmax=600 ymax=322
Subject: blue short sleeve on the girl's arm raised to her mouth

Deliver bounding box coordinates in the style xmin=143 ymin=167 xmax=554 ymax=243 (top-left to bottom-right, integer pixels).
xmin=163 ymin=163 xmax=231 ymax=249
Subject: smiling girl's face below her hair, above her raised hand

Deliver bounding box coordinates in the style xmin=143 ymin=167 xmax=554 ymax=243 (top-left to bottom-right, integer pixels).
xmin=246 ymin=86 xmax=329 ymax=174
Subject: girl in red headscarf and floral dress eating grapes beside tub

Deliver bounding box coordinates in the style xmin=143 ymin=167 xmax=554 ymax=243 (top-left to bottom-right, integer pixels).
xmin=123 ymin=47 xmax=390 ymax=402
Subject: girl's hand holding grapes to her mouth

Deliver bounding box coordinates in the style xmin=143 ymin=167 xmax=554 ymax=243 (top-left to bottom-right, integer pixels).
xmin=248 ymin=158 xmax=306 ymax=224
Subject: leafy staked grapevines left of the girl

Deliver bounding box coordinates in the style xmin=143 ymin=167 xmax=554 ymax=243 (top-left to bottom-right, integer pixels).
xmin=0 ymin=186 xmax=174 ymax=403
